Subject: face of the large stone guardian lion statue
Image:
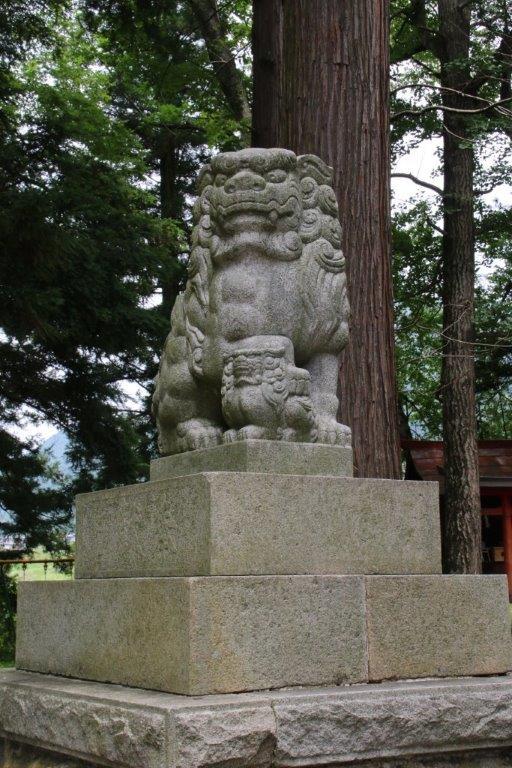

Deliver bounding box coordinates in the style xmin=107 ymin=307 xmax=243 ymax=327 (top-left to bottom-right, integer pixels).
xmin=209 ymin=149 xmax=302 ymax=235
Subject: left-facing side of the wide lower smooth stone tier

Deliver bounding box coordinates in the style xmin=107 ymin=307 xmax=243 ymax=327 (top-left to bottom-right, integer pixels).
xmin=16 ymin=579 xmax=191 ymax=693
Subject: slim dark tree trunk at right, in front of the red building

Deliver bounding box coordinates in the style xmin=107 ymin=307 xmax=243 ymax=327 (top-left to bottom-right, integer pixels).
xmin=439 ymin=0 xmax=482 ymax=573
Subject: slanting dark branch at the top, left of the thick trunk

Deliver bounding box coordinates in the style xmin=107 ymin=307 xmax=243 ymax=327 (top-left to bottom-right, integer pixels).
xmin=189 ymin=0 xmax=251 ymax=127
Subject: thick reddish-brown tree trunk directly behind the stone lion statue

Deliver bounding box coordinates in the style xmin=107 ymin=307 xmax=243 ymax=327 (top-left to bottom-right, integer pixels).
xmin=253 ymin=0 xmax=400 ymax=477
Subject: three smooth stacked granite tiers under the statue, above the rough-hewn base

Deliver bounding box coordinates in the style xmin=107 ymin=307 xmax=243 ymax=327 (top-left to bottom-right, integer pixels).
xmin=12 ymin=441 xmax=512 ymax=696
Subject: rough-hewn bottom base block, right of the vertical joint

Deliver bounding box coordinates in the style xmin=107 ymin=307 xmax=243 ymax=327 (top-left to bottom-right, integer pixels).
xmin=273 ymin=679 xmax=512 ymax=766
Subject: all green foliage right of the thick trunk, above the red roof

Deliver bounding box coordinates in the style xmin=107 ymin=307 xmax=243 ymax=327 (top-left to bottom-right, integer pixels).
xmin=391 ymin=0 xmax=512 ymax=439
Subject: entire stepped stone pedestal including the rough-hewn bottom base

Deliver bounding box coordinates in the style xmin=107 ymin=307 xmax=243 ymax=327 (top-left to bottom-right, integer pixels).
xmin=0 ymin=441 xmax=512 ymax=768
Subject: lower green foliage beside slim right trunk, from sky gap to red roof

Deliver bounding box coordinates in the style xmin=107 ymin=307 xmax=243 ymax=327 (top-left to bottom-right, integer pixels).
xmin=393 ymin=195 xmax=512 ymax=439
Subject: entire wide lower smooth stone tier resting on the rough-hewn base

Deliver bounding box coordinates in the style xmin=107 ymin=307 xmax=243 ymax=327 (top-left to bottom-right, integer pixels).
xmin=16 ymin=575 xmax=512 ymax=695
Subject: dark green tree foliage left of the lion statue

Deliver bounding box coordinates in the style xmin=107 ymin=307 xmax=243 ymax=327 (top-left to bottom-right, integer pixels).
xmin=0 ymin=3 xmax=170 ymax=551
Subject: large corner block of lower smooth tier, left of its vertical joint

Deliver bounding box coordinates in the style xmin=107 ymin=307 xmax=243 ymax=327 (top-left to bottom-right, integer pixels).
xmin=16 ymin=576 xmax=367 ymax=695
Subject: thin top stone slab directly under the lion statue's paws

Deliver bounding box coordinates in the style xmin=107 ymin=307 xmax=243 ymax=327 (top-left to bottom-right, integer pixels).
xmin=150 ymin=440 xmax=353 ymax=480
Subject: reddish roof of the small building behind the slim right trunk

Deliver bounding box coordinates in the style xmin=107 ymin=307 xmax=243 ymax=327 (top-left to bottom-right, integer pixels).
xmin=402 ymin=440 xmax=512 ymax=487
